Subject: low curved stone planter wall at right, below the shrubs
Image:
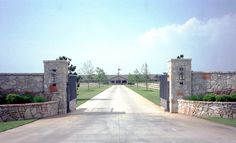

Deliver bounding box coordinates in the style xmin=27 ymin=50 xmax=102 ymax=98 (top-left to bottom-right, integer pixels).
xmin=178 ymin=99 xmax=236 ymax=119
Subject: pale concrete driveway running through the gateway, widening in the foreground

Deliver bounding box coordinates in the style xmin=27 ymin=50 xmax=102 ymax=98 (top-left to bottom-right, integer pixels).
xmin=0 ymin=86 xmax=236 ymax=143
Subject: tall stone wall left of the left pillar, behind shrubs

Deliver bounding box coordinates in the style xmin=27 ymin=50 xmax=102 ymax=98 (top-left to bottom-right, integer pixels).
xmin=0 ymin=73 xmax=44 ymax=93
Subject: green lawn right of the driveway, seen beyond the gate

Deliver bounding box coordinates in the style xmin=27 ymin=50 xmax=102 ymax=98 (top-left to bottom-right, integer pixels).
xmin=127 ymin=86 xmax=160 ymax=106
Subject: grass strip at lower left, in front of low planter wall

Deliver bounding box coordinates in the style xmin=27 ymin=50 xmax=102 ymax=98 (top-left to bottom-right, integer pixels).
xmin=0 ymin=119 xmax=36 ymax=132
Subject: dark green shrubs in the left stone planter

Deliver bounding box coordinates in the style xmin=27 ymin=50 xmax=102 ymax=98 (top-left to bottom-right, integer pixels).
xmin=1 ymin=94 xmax=46 ymax=104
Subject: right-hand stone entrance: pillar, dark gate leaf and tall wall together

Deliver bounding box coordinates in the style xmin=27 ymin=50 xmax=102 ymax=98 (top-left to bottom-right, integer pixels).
xmin=160 ymin=58 xmax=236 ymax=113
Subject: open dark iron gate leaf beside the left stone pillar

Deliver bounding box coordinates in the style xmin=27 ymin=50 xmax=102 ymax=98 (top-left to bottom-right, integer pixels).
xmin=67 ymin=75 xmax=77 ymax=113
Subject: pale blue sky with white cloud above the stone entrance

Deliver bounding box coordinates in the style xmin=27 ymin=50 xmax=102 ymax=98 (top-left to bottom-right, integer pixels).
xmin=0 ymin=0 xmax=236 ymax=74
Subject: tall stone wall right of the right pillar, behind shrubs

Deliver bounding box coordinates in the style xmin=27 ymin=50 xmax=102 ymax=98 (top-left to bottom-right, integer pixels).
xmin=192 ymin=72 xmax=236 ymax=95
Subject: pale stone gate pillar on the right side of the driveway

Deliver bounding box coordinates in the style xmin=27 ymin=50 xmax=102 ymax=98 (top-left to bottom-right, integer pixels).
xmin=168 ymin=59 xmax=192 ymax=113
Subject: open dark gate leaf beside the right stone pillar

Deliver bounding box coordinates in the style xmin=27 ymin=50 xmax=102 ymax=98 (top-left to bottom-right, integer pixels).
xmin=160 ymin=74 xmax=170 ymax=112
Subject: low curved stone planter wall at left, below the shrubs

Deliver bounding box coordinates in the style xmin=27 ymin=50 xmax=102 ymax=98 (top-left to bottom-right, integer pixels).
xmin=0 ymin=101 xmax=58 ymax=121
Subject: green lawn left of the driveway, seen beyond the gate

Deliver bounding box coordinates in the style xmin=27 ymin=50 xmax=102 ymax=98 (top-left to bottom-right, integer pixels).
xmin=77 ymin=85 xmax=111 ymax=106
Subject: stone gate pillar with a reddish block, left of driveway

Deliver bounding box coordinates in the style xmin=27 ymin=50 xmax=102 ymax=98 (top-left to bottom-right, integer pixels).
xmin=44 ymin=60 xmax=68 ymax=114
